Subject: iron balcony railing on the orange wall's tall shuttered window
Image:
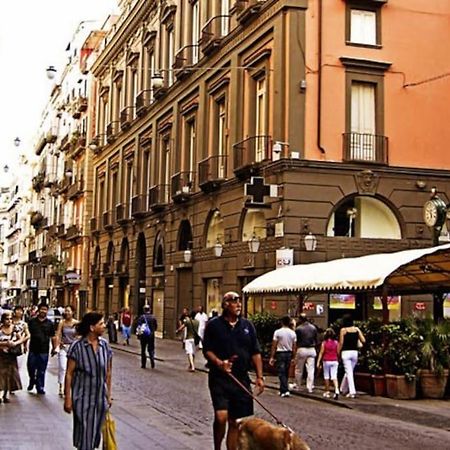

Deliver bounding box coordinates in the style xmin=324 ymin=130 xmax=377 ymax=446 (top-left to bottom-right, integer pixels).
xmin=342 ymin=133 xmax=388 ymax=164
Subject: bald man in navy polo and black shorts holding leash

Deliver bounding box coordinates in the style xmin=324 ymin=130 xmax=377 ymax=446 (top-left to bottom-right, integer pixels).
xmin=203 ymin=292 xmax=264 ymax=450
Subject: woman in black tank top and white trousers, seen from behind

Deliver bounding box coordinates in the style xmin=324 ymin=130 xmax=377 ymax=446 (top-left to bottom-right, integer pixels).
xmin=338 ymin=314 xmax=366 ymax=398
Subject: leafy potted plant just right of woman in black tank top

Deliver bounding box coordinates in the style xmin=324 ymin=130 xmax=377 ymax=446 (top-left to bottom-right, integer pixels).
xmin=382 ymin=320 xmax=420 ymax=399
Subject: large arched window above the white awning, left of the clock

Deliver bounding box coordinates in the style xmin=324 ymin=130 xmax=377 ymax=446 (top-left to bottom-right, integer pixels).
xmin=327 ymin=196 xmax=402 ymax=239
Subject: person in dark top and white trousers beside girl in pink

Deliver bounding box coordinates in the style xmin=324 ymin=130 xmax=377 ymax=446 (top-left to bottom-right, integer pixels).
xmin=295 ymin=313 xmax=317 ymax=393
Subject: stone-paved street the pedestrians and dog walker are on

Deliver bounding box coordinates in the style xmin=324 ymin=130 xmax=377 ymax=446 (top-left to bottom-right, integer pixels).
xmin=0 ymin=343 xmax=450 ymax=450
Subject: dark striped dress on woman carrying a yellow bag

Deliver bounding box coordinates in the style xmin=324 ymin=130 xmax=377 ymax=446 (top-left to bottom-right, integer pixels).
xmin=67 ymin=338 xmax=112 ymax=450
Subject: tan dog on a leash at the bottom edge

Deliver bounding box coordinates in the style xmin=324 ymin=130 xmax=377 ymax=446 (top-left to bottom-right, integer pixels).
xmin=237 ymin=417 xmax=310 ymax=450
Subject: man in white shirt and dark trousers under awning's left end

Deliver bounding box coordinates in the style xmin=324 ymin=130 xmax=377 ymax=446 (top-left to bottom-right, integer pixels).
xmin=269 ymin=316 xmax=297 ymax=397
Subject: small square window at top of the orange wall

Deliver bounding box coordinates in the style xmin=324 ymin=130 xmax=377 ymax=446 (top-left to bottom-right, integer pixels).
xmin=345 ymin=0 xmax=386 ymax=48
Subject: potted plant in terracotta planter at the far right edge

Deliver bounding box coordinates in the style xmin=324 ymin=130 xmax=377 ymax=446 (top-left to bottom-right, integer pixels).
xmin=412 ymin=317 xmax=450 ymax=398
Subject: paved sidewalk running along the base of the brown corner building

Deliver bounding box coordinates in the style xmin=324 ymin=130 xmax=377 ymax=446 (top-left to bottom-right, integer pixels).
xmin=112 ymin=336 xmax=450 ymax=420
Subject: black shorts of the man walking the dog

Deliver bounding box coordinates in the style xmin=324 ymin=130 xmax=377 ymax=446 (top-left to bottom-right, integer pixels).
xmin=208 ymin=374 xmax=253 ymax=419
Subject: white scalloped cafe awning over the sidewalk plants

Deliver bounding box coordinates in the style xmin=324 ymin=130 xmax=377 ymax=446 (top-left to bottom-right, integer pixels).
xmin=243 ymin=244 xmax=450 ymax=295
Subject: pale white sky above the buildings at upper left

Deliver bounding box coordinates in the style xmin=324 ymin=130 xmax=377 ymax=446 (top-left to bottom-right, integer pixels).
xmin=0 ymin=0 xmax=118 ymax=185
